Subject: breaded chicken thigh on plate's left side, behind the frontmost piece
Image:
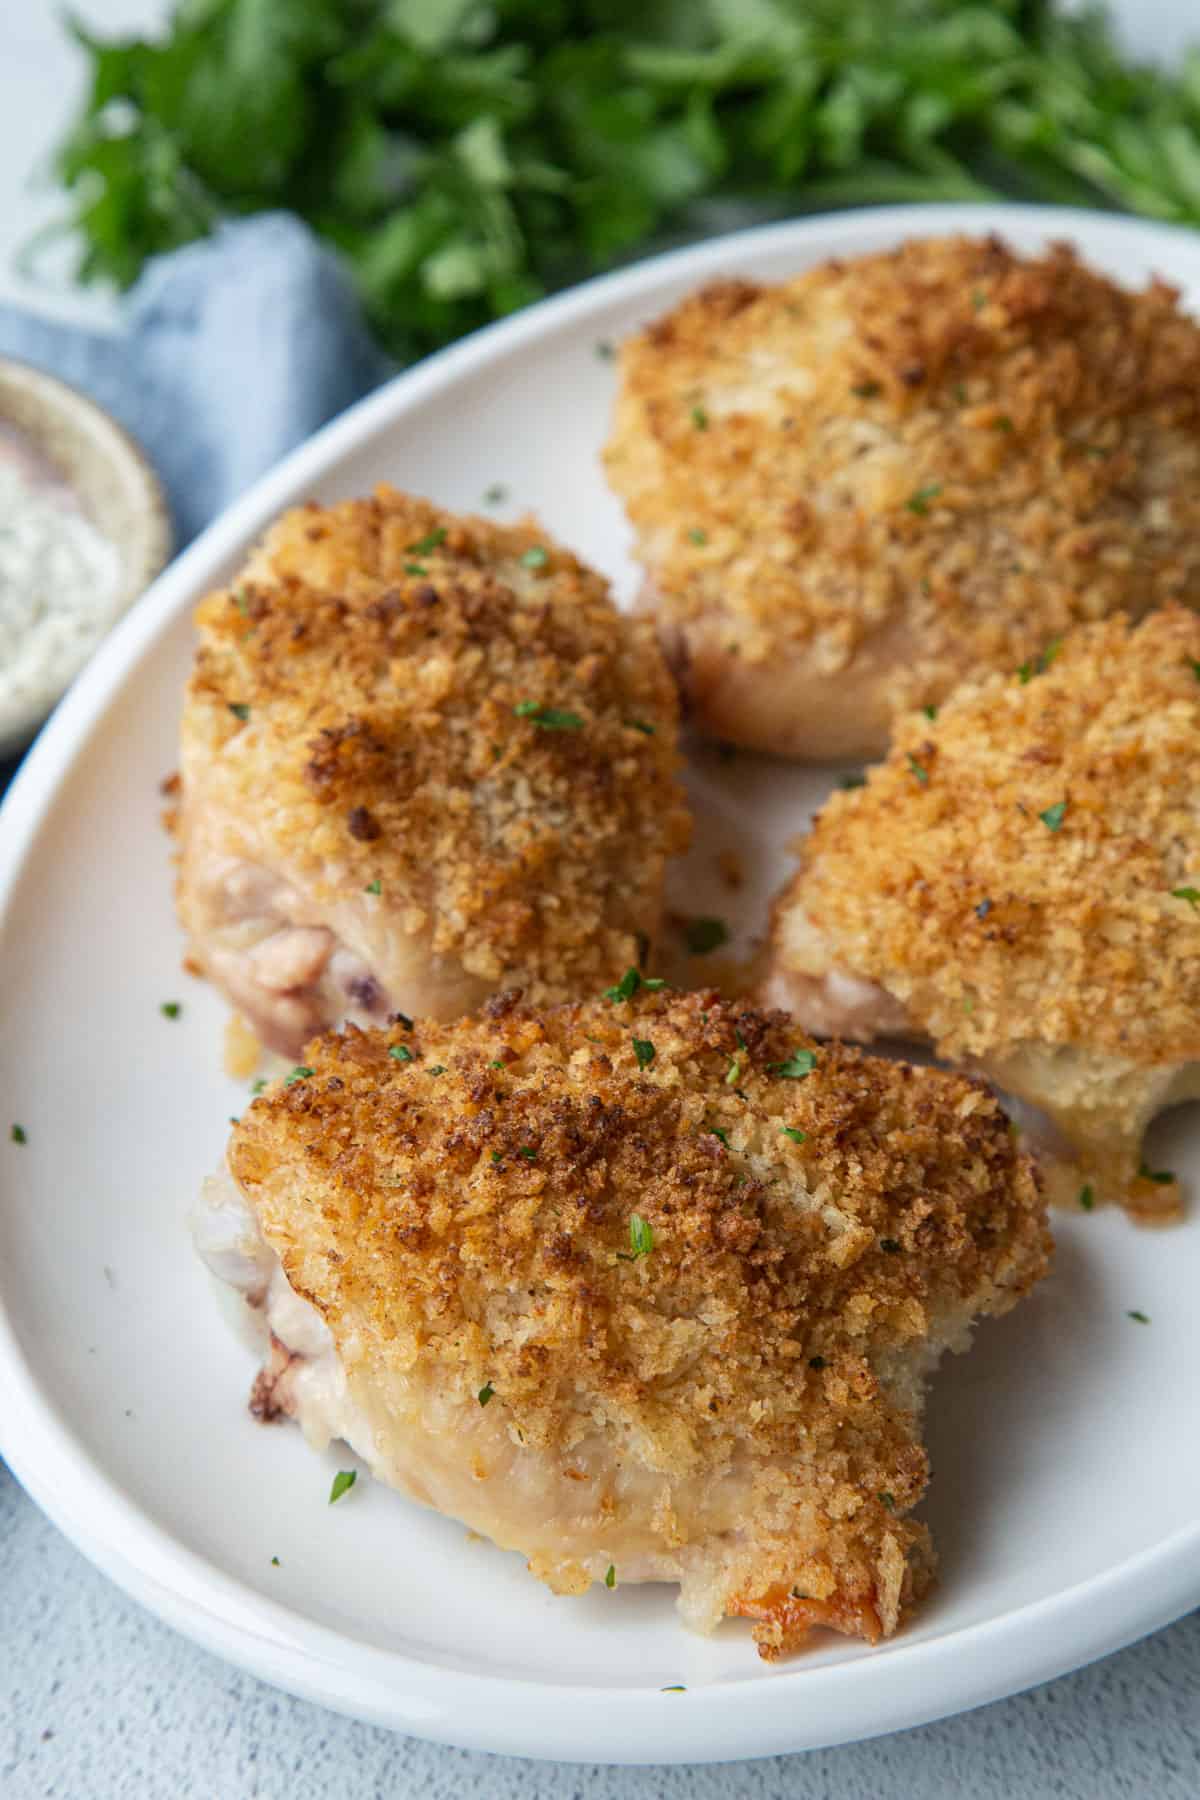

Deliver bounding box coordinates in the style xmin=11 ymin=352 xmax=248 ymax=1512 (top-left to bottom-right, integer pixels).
xmin=176 ymin=490 xmax=689 ymax=1055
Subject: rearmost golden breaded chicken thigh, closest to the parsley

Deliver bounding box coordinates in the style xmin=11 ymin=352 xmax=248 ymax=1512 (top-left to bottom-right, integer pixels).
xmin=606 ymin=238 xmax=1200 ymax=760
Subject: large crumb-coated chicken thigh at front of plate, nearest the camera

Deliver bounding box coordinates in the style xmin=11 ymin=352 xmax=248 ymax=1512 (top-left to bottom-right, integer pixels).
xmin=200 ymin=977 xmax=1049 ymax=1658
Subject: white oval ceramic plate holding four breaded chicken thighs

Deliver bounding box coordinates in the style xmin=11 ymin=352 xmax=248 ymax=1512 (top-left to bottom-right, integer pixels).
xmin=0 ymin=207 xmax=1200 ymax=1762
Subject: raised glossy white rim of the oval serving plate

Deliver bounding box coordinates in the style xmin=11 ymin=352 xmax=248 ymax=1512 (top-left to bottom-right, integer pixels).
xmin=0 ymin=203 xmax=1200 ymax=1764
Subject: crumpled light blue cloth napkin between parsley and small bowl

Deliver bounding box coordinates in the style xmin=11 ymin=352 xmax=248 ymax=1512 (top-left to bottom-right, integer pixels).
xmin=0 ymin=212 xmax=394 ymax=794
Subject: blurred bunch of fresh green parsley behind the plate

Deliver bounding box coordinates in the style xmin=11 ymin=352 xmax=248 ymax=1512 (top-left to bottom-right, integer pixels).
xmin=58 ymin=0 xmax=1200 ymax=360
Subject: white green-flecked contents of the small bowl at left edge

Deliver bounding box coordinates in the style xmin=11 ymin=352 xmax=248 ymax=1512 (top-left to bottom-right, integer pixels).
xmin=0 ymin=427 xmax=121 ymax=745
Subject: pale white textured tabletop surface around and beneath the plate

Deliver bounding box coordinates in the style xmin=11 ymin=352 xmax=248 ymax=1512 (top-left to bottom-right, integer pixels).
xmin=0 ymin=0 xmax=1200 ymax=1800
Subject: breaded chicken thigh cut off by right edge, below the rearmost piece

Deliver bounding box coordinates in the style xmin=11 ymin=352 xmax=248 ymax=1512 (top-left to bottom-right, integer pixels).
xmin=763 ymin=607 xmax=1200 ymax=1215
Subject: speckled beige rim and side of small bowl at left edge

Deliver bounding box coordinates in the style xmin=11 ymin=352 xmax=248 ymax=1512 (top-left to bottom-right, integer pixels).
xmin=0 ymin=356 xmax=171 ymax=756
